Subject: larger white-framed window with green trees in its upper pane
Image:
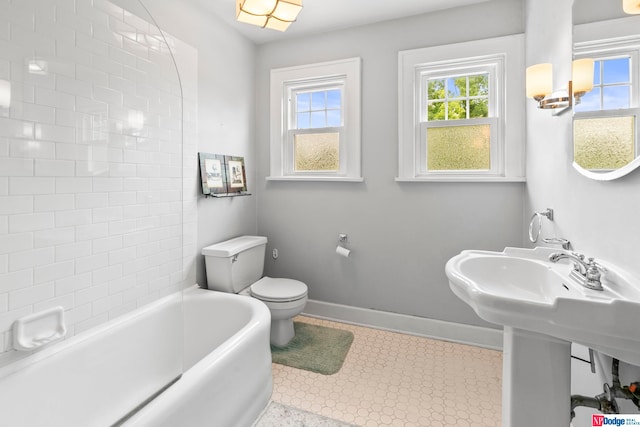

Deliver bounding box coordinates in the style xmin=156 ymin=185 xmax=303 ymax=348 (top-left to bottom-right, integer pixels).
xmin=397 ymin=35 xmax=524 ymax=181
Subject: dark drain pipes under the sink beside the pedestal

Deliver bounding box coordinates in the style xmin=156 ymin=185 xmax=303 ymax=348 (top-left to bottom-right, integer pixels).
xmin=571 ymin=359 xmax=640 ymax=420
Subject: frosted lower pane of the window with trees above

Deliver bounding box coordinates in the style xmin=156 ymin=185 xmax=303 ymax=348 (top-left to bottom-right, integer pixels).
xmin=427 ymin=125 xmax=491 ymax=171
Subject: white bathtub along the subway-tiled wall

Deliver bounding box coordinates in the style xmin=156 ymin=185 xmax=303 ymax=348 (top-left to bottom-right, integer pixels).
xmin=0 ymin=286 xmax=272 ymax=427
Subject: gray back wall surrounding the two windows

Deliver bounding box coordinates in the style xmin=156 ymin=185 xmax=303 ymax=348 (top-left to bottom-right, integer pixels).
xmin=255 ymin=0 xmax=524 ymax=326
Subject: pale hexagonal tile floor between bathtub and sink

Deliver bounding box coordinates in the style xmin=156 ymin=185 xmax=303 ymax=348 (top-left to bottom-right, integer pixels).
xmin=272 ymin=316 xmax=502 ymax=427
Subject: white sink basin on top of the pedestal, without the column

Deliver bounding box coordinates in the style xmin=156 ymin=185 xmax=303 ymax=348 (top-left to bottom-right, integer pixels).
xmin=446 ymin=248 xmax=640 ymax=365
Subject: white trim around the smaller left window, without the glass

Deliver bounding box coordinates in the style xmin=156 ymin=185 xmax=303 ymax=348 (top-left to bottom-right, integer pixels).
xmin=267 ymin=58 xmax=363 ymax=182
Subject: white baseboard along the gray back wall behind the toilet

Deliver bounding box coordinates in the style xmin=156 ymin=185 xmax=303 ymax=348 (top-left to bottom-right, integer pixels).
xmin=302 ymin=300 xmax=502 ymax=351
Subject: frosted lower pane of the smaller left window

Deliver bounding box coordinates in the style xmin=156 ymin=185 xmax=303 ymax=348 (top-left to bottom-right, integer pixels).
xmin=294 ymin=132 xmax=340 ymax=172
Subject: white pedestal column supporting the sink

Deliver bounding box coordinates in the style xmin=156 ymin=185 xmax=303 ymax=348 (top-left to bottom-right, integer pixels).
xmin=502 ymin=326 xmax=571 ymax=427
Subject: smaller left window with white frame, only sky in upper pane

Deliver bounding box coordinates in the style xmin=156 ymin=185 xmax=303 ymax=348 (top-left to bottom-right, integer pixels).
xmin=268 ymin=58 xmax=362 ymax=181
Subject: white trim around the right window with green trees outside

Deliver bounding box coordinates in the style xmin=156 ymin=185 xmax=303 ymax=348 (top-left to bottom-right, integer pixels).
xmin=396 ymin=34 xmax=525 ymax=182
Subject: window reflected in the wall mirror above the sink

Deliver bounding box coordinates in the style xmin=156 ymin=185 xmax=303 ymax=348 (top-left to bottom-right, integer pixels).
xmin=573 ymin=39 xmax=640 ymax=172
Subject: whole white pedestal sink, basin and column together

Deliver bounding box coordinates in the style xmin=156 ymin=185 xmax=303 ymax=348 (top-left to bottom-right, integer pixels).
xmin=446 ymin=248 xmax=640 ymax=427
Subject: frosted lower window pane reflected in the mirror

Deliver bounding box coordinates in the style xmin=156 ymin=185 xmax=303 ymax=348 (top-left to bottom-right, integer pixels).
xmin=573 ymin=116 xmax=635 ymax=170
